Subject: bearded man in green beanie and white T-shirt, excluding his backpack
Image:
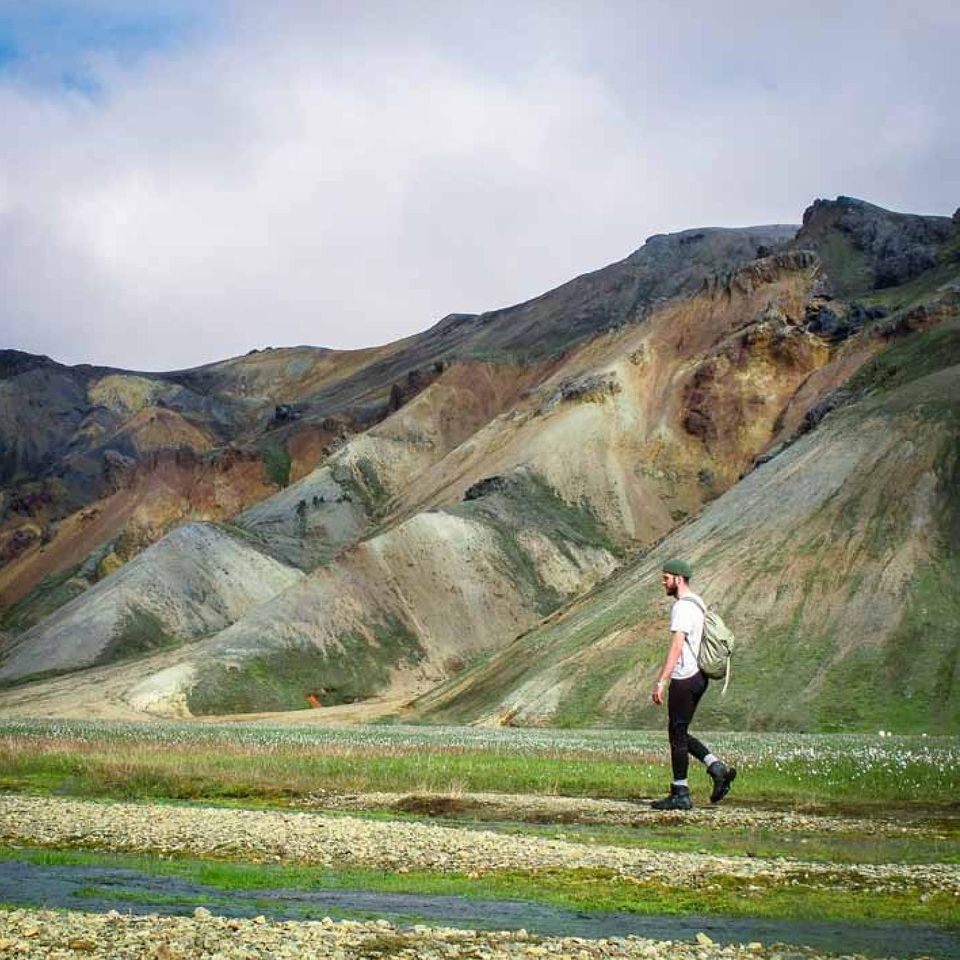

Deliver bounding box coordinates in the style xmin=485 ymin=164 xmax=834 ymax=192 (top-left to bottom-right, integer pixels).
xmin=651 ymin=560 xmax=737 ymax=810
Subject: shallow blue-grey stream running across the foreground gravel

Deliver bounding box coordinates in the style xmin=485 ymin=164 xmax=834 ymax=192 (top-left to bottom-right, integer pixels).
xmin=0 ymin=860 xmax=960 ymax=960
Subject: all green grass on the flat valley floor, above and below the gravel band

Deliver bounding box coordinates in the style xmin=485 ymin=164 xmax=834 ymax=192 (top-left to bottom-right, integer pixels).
xmin=0 ymin=721 xmax=960 ymax=944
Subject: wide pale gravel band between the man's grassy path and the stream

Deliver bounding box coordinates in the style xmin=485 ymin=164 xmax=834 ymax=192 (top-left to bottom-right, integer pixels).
xmin=0 ymin=796 xmax=960 ymax=897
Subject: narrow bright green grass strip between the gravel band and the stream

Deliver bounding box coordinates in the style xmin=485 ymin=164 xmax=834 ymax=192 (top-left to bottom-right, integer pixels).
xmin=0 ymin=848 xmax=957 ymax=928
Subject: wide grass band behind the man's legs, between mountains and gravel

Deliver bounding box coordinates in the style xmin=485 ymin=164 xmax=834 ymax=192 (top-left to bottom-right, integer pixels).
xmin=0 ymin=722 xmax=960 ymax=813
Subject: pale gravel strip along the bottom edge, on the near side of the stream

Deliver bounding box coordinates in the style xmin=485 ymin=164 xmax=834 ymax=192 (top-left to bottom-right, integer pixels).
xmin=0 ymin=907 xmax=896 ymax=960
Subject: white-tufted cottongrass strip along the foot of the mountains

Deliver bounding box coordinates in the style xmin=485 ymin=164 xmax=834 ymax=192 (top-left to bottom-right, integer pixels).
xmin=0 ymin=719 xmax=960 ymax=802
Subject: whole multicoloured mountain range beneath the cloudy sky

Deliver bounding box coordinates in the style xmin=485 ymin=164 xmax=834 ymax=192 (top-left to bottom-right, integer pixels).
xmin=0 ymin=197 xmax=960 ymax=730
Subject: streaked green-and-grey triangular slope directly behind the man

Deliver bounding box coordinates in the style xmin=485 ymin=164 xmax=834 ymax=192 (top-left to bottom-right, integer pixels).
xmin=417 ymin=318 xmax=960 ymax=732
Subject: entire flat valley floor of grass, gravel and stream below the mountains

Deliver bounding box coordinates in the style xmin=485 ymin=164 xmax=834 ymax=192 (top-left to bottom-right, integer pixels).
xmin=0 ymin=719 xmax=960 ymax=960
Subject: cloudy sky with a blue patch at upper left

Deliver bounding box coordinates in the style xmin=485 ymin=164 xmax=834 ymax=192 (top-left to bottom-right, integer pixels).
xmin=0 ymin=0 xmax=960 ymax=371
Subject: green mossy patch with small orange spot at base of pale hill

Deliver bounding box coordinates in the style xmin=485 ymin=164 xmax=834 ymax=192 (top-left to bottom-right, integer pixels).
xmin=187 ymin=618 xmax=426 ymax=716
